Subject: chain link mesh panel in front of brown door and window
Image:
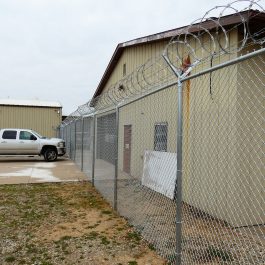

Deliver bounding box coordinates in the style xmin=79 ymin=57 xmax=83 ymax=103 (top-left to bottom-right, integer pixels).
xmin=117 ymin=86 xmax=177 ymax=260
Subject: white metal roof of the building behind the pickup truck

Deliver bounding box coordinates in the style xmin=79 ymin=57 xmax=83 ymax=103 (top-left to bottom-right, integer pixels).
xmin=0 ymin=98 xmax=62 ymax=108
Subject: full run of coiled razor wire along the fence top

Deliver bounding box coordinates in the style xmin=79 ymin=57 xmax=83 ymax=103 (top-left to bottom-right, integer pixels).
xmin=62 ymin=0 xmax=265 ymax=126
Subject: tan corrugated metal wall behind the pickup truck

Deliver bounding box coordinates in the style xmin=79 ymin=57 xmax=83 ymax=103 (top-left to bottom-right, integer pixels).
xmin=0 ymin=105 xmax=62 ymax=137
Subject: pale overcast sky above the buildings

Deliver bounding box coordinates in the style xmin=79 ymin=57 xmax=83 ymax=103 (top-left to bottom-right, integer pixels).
xmin=0 ymin=0 xmax=265 ymax=115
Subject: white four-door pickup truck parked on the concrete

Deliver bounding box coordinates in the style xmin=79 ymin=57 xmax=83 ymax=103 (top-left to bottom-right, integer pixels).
xmin=0 ymin=128 xmax=66 ymax=162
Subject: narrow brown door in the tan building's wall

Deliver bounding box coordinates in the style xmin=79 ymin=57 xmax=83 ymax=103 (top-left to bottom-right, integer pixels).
xmin=123 ymin=125 xmax=132 ymax=174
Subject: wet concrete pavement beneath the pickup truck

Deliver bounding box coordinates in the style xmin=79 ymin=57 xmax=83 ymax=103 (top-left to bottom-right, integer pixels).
xmin=0 ymin=156 xmax=88 ymax=185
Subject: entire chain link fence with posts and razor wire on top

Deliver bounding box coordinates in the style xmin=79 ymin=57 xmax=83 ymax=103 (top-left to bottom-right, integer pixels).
xmin=57 ymin=1 xmax=265 ymax=265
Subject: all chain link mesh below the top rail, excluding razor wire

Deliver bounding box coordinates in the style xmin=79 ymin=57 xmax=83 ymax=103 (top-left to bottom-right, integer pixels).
xmin=60 ymin=50 xmax=265 ymax=265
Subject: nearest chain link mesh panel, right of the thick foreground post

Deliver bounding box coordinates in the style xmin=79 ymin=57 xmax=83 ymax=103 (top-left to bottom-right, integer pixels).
xmin=182 ymin=54 xmax=265 ymax=264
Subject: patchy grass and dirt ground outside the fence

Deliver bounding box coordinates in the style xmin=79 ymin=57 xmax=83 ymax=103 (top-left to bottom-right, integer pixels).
xmin=0 ymin=181 xmax=166 ymax=265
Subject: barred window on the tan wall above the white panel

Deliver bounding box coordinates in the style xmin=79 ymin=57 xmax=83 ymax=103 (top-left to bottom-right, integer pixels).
xmin=154 ymin=122 xmax=167 ymax=152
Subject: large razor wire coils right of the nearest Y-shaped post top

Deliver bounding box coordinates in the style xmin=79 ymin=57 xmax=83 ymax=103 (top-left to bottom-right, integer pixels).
xmin=164 ymin=0 xmax=265 ymax=71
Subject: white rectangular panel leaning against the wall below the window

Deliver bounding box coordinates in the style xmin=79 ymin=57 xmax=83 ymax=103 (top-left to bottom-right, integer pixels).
xmin=142 ymin=150 xmax=177 ymax=199
